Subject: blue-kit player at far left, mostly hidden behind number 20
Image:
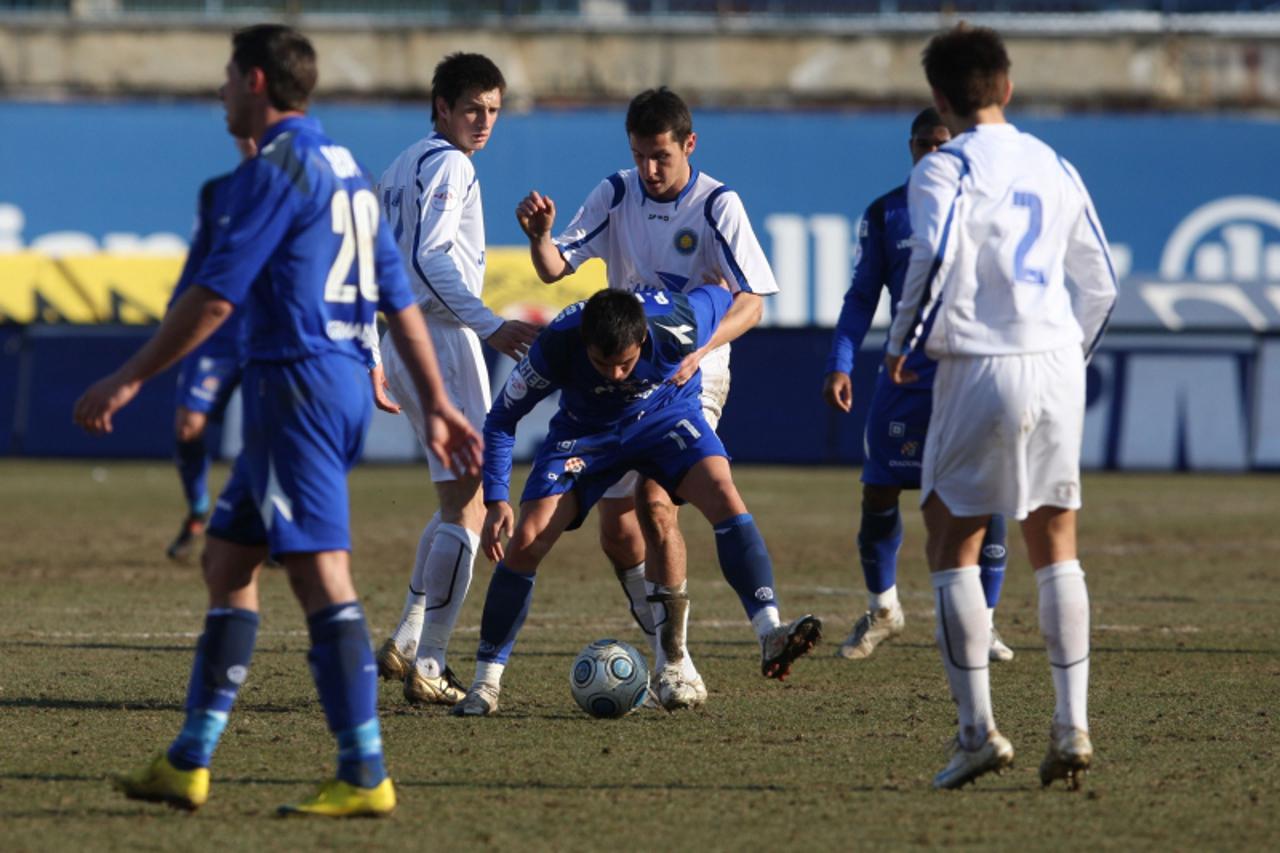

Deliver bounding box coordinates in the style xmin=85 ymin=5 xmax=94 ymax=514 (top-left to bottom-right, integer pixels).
xmin=165 ymin=134 xmax=257 ymax=560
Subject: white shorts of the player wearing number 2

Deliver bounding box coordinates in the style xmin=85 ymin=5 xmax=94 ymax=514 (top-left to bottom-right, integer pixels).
xmin=920 ymin=346 xmax=1084 ymax=520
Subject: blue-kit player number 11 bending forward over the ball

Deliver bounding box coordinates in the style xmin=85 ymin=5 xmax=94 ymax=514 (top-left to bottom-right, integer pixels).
xmin=451 ymin=286 xmax=812 ymax=716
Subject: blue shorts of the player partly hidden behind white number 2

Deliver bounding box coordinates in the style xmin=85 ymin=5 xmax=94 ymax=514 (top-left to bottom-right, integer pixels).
xmin=863 ymin=370 xmax=933 ymax=489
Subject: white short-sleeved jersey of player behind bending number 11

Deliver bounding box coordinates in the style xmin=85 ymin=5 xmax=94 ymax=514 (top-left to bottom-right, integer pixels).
xmin=556 ymin=169 xmax=778 ymax=373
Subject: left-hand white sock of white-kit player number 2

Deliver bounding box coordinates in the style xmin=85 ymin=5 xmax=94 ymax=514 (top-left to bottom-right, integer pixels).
xmin=931 ymin=566 xmax=996 ymax=749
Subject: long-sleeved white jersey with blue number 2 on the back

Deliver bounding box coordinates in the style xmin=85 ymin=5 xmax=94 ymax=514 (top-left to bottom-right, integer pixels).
xmin=888 ymin=124 xmax=1116 ymax=359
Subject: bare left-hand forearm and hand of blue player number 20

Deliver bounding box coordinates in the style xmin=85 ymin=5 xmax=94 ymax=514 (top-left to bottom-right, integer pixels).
xmin=74 ymin=286 xmax=234 ymax=434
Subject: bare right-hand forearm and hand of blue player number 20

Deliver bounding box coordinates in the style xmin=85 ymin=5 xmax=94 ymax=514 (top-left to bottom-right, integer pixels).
xmin=387 ymin=305 xmax=484 ymax=476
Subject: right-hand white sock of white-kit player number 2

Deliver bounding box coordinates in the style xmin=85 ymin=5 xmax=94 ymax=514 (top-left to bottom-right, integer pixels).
xmin=1036 ymin=560 xmax=1089 ymax=731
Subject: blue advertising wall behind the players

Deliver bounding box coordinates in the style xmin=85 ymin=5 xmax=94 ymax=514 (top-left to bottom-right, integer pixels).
xmin=0 ymin=102 xmax=1280 ymax=470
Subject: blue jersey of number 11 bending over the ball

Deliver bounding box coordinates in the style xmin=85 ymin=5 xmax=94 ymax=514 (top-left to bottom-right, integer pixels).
xmin=484 ymin=286 xmax=733 ymax=501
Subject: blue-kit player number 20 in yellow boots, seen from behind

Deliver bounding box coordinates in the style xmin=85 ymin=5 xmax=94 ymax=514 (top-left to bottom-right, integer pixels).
xmin=76 ymin=24 xmax=480 ymax=816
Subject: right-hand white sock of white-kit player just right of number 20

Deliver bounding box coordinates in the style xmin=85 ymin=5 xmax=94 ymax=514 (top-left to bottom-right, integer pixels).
xmin=415 ymin=524 xmax=480 ymax=678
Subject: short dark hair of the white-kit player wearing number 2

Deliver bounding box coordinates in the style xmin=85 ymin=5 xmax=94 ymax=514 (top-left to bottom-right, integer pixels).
xmin=923 ymin=23 xmax=1012 ymax=117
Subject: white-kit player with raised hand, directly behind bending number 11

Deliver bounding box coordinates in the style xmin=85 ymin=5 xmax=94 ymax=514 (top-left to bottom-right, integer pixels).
xmin=516 ymin=87 xmax=822 ymax=710
